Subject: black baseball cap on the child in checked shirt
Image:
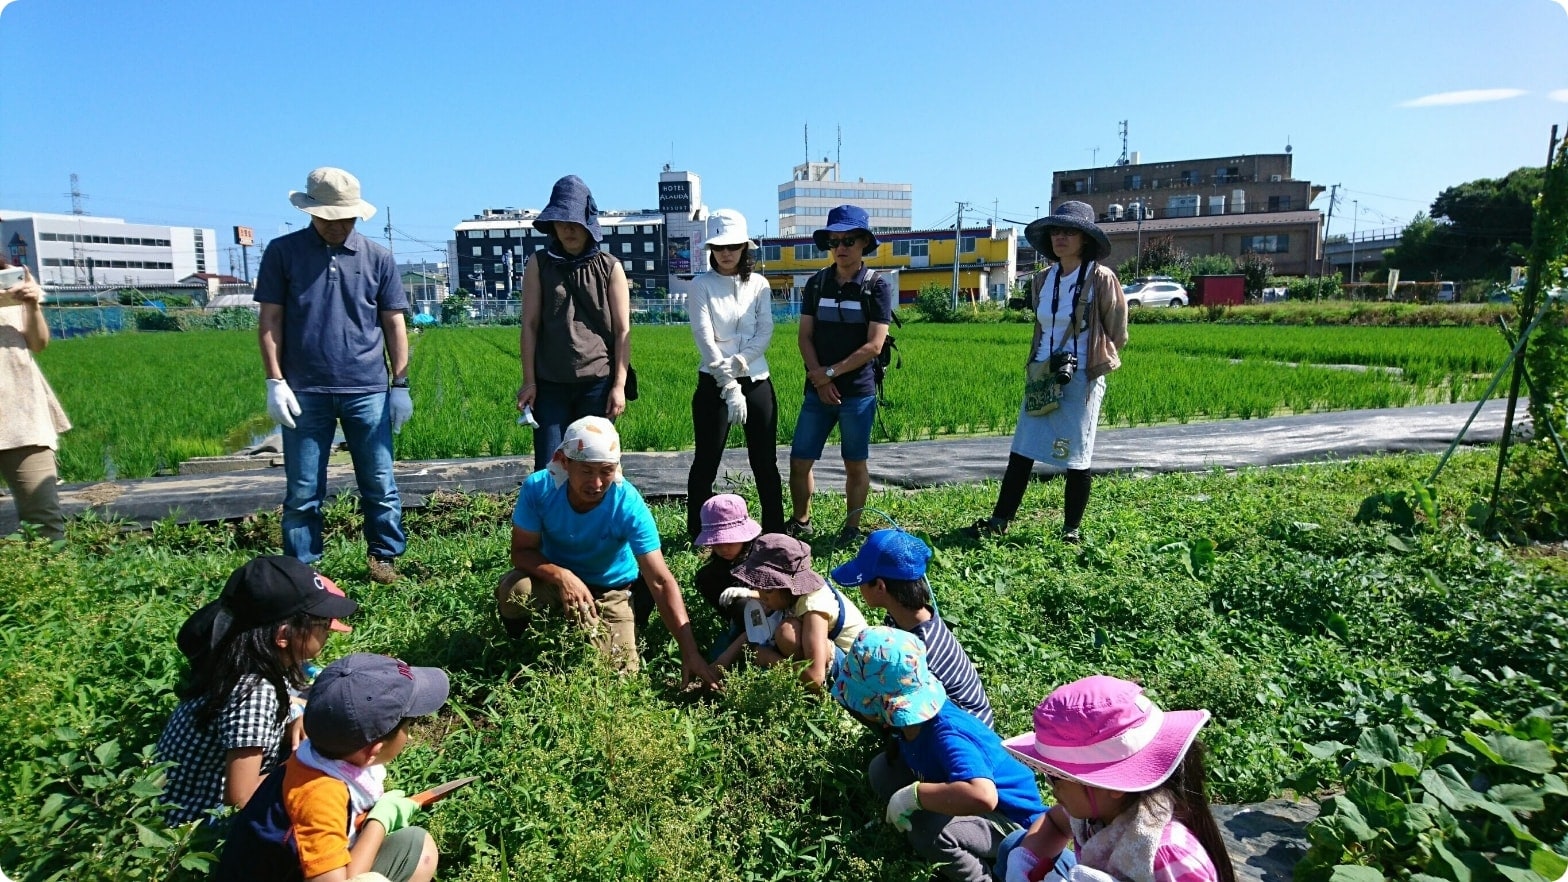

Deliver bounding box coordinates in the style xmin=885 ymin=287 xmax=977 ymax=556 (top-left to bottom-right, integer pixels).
xmin=176 ymin=554 xmax=359 ymax=661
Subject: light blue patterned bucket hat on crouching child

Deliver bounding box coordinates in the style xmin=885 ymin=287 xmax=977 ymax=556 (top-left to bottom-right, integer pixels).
xmin=833 ymin=625 xmax=947 ymax=727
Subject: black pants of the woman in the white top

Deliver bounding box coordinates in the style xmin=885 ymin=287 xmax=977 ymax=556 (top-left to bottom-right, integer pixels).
xmin=687 ymin=370 xmax=784 ymax=537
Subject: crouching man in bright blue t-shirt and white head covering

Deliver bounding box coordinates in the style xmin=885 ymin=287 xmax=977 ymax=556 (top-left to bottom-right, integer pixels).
xmin=495 ymin=416 xmax=718 ymax=687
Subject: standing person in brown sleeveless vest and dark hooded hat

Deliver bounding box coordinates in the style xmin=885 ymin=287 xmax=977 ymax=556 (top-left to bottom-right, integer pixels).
xmin=517 ymin=174 xmax=632 ymax=471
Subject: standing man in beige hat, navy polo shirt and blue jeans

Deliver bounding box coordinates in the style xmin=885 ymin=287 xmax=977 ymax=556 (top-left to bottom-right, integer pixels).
xmin=256 ymin=168 xmax=414 ymax=584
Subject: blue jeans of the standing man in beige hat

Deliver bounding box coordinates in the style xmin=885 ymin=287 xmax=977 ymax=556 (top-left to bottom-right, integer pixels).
xmin=284 ymin=392 xmax=408 ymax=563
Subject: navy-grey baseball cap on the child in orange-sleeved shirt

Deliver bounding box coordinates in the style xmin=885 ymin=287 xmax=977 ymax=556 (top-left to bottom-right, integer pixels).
xmin=304 ymin=653 xmax=452 ymax=758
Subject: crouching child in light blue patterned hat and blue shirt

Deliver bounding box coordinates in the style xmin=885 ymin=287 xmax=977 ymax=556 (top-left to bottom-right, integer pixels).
xmin=833 ymin=626 xmax=1046 ymax=882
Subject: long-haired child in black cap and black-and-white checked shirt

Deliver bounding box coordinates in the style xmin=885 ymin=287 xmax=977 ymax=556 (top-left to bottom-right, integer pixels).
xmin=157 ymin=556 xmax=359 ymax=824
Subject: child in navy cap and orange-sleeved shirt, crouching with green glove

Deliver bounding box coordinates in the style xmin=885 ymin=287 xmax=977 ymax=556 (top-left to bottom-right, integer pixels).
xmin=216 ymin=653 xmax=448 ymax=882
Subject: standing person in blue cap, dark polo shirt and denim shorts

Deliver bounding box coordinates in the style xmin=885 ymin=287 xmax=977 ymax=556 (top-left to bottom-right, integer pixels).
xmin=784 ymin=206 xmax=897 ymax=541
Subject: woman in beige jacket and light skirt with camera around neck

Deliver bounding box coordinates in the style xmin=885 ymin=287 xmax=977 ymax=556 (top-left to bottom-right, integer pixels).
xmin=969 ymin=202 xmax=1127 ymax=543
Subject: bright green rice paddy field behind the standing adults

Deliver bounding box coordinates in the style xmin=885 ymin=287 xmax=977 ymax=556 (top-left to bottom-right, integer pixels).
xmin=39 ymin=323 xmax=1505 ymax=482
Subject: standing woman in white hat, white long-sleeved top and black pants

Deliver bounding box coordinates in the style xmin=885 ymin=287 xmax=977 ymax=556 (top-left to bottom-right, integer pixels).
xmin=687 ymin=209 xmax=784 ymax=537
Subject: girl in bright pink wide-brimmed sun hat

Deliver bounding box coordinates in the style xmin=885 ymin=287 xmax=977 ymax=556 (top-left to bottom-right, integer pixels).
xmin=997 ymin=676 xmax=1236 ymax=882
